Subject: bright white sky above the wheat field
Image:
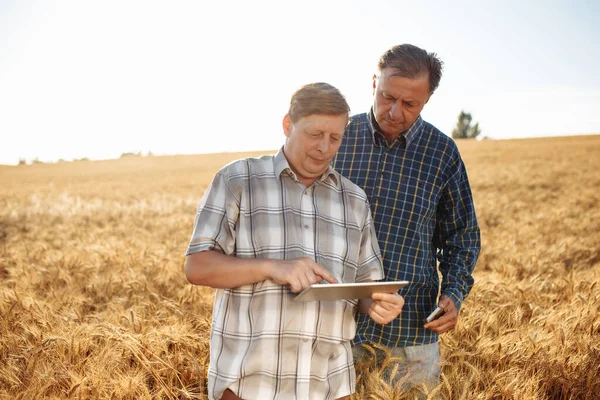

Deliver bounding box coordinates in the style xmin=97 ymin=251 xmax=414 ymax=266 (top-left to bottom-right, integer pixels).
xmin=0 ymin=0 xmax=600 ymax=164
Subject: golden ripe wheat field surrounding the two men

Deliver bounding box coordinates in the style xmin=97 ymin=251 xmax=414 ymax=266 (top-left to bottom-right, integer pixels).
xmin=0 ymin=135 xmax=600 ymax=400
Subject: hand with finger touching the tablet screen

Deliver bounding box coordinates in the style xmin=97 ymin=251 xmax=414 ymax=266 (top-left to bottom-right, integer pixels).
xmin=268 ymin=257 xmax=337 ymax=293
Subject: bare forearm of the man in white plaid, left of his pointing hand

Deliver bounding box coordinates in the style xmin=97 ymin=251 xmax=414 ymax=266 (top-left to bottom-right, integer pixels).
xmin=185 ymin=250 xmax=273 ymax=289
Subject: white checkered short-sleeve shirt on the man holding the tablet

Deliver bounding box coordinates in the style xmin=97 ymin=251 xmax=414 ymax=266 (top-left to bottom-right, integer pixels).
xmin=187 ymin=150 xmax=383 ymax=400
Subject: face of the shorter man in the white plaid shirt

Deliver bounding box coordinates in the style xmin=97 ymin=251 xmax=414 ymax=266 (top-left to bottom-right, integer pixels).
xmin=283 ymin=114 xmax=348 ymax=186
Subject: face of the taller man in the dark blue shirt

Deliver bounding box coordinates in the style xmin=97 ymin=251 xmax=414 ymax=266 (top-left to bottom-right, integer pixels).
xmin=373 ymin=68 xmax=430 ymax=140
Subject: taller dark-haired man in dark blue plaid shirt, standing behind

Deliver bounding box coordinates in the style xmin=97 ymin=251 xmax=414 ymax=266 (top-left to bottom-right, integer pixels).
xmin=332 ymin=44 xmax=480 ymax=388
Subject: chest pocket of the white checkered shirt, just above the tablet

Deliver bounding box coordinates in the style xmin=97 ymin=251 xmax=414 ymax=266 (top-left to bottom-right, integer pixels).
xmin=317 ymin=220 xmax=361 ymax=283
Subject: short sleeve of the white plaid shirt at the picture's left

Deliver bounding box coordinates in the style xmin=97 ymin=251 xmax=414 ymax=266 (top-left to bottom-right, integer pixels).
xmin=186 ymin=170 xmax=240 ymax=255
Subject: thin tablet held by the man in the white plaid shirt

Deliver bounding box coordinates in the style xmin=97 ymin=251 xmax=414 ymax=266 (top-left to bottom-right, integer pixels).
xmin=294 ymin=281 xmax=408 ymax=301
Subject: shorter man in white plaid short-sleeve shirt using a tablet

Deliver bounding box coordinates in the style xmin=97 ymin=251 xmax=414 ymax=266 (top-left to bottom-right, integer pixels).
xmin=185 ymin=83 xmax=404 ymax=400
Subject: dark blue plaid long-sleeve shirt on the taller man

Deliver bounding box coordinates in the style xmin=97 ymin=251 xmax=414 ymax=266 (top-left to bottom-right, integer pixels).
xmin=332 ymin=113 xmax=481 ymax=347
